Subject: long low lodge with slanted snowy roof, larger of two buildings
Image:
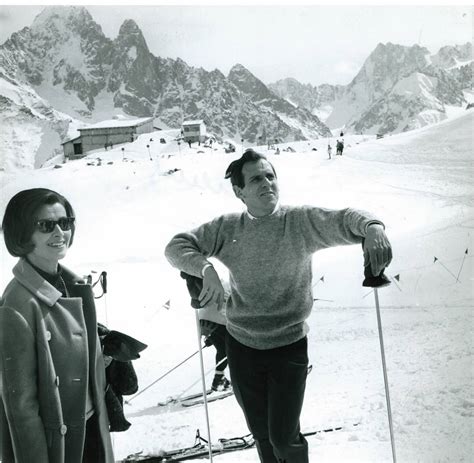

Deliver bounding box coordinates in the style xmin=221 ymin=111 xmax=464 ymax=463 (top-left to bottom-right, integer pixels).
xmin=62 ymin=117 xmax=154 ymax=159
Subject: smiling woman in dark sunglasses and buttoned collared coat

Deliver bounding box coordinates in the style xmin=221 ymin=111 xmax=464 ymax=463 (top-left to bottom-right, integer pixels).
xmin=0 ymin=188 xmax=114 ymax=463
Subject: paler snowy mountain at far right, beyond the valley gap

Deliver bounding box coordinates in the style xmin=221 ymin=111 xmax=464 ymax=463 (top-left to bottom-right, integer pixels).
xmin=288 ymin=43 xmax=473 ymax=134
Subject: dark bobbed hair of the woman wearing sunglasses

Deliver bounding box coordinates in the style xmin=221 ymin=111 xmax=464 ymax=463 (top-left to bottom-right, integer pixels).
xmin=2 ymin=188 xmax=75 ymax=257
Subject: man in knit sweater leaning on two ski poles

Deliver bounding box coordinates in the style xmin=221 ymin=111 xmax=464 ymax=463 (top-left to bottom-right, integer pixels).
xmin=165 ymin=149 xmax=392 ymax=463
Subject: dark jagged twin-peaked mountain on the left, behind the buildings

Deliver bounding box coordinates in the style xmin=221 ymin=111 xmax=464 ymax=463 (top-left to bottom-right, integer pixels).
xmin=0 ymin=6 xmax=330 ymax=170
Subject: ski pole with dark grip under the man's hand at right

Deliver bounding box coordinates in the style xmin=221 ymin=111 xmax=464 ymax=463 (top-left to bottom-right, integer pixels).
xmin=362 ymin=265 xmax=397 ymax=463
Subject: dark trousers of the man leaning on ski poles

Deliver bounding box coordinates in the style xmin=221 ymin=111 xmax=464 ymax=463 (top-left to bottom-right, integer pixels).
xmin=226 ymin=333 xmax=308 ymax=463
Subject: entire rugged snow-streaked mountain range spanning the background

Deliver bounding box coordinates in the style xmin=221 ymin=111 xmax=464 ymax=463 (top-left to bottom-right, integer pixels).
xmin=0 ymin=6 xmax=472 ymax=169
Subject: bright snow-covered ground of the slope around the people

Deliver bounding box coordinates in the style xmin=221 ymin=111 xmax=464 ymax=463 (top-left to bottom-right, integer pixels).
xmin=0 ymin=110 xmax=474 ymax=463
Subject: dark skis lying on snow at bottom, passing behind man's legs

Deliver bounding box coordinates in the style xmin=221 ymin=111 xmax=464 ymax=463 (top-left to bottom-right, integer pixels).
xmin=121 ymin=423 xmax=359 ymax=463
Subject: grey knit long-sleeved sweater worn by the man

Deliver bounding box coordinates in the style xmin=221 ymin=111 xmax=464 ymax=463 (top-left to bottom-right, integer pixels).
xmin=165 ymin=206 xmax=381 ymax=349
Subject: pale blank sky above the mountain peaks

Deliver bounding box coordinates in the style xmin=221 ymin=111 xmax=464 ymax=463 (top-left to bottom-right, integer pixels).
xmin=0 ymin=1 xmax=473 ymax=85
